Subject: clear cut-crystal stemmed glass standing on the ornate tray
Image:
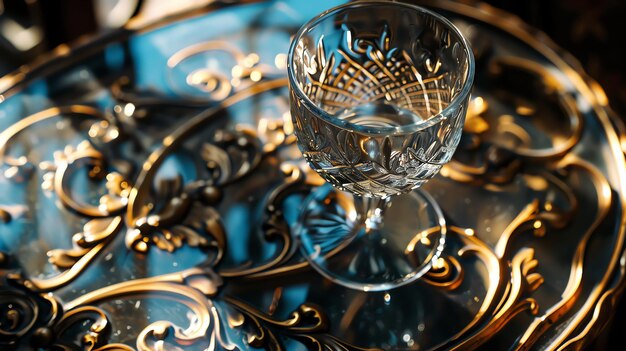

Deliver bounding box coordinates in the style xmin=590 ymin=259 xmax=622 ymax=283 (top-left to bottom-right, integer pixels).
xmin=288 ymin=1 xmax=474 ymax=291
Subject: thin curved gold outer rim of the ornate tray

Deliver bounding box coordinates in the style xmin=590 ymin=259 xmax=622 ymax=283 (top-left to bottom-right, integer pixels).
xmin=0 ymin=0 xmax=626 ymax=349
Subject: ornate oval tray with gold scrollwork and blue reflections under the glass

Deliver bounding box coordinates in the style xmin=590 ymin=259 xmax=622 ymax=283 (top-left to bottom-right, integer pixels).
xmin=0 ymin=0 xmax=626 ymax=350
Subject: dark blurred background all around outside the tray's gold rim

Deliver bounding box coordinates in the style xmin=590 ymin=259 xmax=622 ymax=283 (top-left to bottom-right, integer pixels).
xmin=0 ymin=0 xmax=626 ymax=350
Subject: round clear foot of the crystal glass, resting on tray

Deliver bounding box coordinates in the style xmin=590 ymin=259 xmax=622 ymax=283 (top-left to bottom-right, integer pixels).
xmin=296 ymin=184 xmax=446 ymax=291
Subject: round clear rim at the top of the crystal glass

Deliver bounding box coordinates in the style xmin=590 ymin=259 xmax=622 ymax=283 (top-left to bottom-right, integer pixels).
xmin=287 ymin=0 xmax=475 ymax=134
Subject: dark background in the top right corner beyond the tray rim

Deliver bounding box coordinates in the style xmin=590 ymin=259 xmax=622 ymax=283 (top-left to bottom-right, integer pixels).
xmin=478 ymin=0 xmax=626 ymax=120
